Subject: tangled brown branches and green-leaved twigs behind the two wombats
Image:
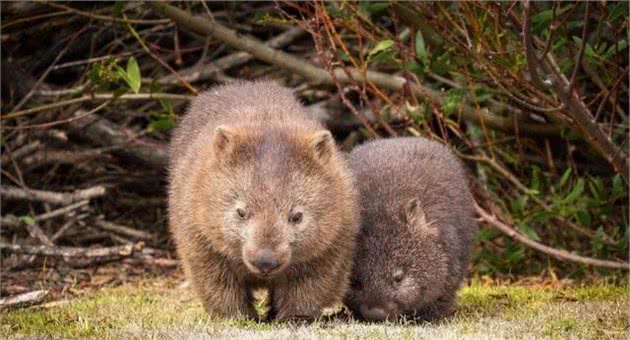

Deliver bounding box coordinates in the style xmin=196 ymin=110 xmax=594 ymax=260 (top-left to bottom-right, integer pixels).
xmin=0 ymin=2 xmax=630 ymax=292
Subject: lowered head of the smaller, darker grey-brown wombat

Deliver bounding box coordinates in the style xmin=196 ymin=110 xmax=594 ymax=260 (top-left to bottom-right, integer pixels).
xmin=346 ymin=199 xmax=447 ymax=321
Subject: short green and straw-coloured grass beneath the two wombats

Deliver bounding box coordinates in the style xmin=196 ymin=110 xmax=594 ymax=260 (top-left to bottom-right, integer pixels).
xmin=0 ymin=280 xmax=630 ymax=339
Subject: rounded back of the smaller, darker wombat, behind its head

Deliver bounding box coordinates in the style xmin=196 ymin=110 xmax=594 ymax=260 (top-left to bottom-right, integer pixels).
xmin=350 ymin=137 xmax=477 ymax=281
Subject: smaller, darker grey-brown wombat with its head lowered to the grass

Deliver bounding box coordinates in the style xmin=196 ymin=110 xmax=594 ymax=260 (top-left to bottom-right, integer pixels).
xmin=345 ymin=138 xmax=477 ymax=321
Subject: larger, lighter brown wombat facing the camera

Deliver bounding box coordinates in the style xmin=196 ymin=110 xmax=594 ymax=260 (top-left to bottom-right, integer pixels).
xmin=168 ymin=81 xmax=359 ymax=319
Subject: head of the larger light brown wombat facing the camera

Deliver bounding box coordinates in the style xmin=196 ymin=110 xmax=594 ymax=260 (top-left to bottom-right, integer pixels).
xmin=199 ymin=126 xmax=354 ymax=277
